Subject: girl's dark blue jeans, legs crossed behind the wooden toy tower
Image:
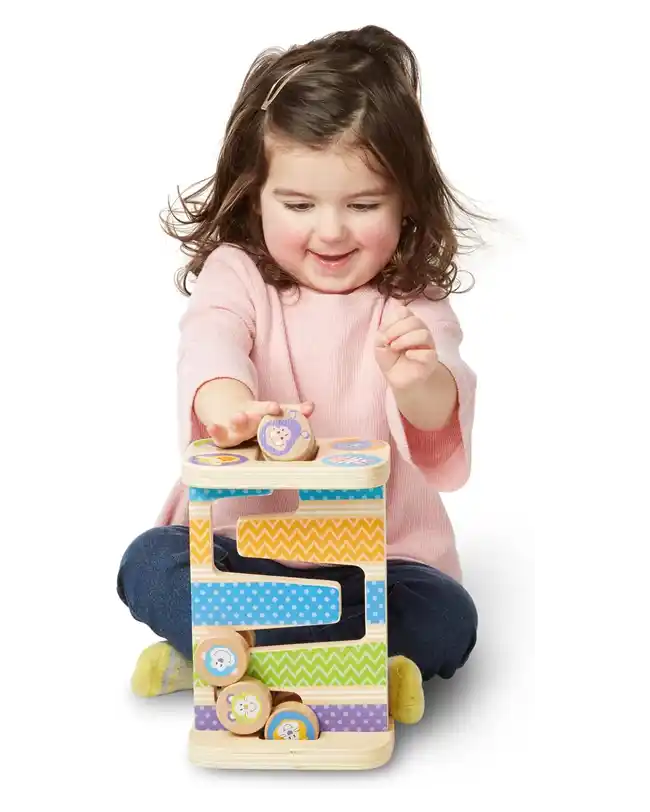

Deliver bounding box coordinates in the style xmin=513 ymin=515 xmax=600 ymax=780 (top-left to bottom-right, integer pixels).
xmin=117 ymin=525 xmax=478 ymax=680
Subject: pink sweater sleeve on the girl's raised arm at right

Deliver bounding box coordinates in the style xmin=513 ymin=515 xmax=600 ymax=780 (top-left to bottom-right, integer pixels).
xmin=386 ymin=299 xmax=476 ymax=492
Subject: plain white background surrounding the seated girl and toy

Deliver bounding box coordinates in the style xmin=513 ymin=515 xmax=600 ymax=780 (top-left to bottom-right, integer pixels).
xmin=0 ymin=0 xmax=650 ymax=810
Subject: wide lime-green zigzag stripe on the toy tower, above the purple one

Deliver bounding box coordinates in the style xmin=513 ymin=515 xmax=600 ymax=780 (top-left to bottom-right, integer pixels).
xmin=247 ymin=643 xmax=386 ymax=688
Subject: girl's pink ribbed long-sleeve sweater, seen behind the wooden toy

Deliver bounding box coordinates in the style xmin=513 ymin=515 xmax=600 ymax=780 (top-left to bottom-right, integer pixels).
xmin=157 ymin=246 xmax=476 ymax=581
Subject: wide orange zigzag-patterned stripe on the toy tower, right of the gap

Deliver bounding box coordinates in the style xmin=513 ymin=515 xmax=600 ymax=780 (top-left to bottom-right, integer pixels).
xmin=237 ymin=514 xmax=385 ymax=564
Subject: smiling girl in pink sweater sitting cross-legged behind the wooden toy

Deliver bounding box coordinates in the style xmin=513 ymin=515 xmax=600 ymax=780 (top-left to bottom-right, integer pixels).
xmin=118 ymin=26 xmax=477 ymax=723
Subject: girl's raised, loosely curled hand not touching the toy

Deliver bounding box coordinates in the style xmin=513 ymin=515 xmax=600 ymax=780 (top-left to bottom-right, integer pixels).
xmin=375 ymin=305 xmax=439 ymax=390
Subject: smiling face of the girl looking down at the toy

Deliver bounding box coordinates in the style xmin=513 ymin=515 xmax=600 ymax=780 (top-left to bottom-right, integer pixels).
xmin=260 ymin=142 xmax=402 ymax=293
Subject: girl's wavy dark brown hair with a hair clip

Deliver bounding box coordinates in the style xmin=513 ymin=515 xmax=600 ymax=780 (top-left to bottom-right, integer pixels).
xmin=162 ymin=26 xmax=490 ymax=299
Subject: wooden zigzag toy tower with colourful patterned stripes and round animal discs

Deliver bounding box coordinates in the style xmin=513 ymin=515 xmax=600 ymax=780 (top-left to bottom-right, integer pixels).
xmin=183 ymin=409 xmax=394 ymax=770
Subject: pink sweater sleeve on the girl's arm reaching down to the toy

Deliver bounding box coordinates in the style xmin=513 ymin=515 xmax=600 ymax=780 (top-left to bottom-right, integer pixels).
xmin=177 ymin=247 xmax=257 ymax=451
